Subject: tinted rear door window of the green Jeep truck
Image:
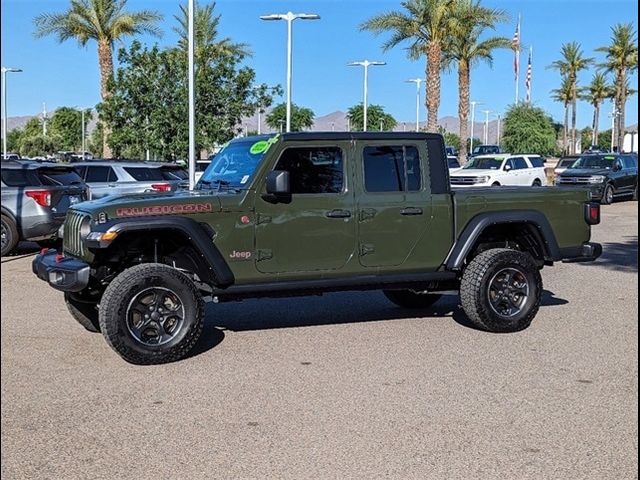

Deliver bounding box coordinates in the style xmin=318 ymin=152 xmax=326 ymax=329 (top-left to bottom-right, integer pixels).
xmin=363 ymin=145 xmax=421 ymax=193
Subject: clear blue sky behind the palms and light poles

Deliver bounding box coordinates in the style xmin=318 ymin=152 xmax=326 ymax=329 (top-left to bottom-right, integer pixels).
xmin=1 ymin=0 xmax=638 ymax=127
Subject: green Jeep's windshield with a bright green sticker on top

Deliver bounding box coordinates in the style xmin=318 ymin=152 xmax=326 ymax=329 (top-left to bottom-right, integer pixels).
xmin=198 ymin=137 xmax=277 ymax=190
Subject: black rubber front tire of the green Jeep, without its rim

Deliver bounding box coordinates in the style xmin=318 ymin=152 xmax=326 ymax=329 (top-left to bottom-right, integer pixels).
xmin=99 ymin=263 xmax=204 ymax=365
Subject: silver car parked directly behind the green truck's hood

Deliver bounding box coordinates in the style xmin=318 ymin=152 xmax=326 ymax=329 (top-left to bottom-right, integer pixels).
xmin=72 ymin=160 xmax=188 ymax=199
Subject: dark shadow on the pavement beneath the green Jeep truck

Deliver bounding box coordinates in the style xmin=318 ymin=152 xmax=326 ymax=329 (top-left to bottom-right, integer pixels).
xmin=198 ymin=290 xmax=569 ymax=344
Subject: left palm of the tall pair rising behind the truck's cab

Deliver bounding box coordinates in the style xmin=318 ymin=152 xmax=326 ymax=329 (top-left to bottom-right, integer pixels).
xmin=360 ymin=0 xmax=459 ymax=132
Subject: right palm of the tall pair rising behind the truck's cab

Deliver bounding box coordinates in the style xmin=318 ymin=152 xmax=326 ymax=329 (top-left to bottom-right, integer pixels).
xmin=443 ymin=0 xmax=512 ymax=163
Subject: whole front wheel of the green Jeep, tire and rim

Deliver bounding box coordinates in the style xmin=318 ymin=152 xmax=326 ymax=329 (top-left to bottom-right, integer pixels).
xmin=100 ymin=263 xmax=204 ymax=365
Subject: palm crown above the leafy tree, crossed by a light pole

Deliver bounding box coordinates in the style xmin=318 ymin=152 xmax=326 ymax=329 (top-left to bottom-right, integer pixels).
xmin=173 ymin=2 xmax=251 ymax=61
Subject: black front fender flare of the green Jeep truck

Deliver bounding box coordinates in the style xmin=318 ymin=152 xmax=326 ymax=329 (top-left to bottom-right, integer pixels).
xmin=87 ymin=216 xmax=235 ymax=288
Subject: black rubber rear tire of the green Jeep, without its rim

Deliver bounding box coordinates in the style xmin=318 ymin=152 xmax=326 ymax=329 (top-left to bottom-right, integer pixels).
xmin=460 ymin=248 xmax=542 ymax=332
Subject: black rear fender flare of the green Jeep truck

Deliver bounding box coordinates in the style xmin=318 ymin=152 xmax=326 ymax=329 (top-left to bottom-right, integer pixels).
xmin=445 ymin=210 xmax=562 ymax=270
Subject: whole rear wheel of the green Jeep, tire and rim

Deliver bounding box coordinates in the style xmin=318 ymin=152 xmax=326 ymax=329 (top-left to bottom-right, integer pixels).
xmin=460 ymin=248 xmax=542 ymax=332
